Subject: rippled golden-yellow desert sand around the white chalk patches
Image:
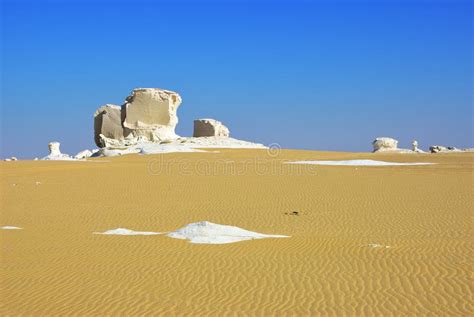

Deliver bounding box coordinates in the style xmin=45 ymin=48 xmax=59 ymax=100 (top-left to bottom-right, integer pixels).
xmin=0 ymin=150 xmax=474 ymax=316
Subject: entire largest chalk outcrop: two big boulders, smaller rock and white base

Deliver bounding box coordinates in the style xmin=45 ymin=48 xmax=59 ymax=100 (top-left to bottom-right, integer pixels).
xmin=89 ymin=88 xmax=266 ymax=156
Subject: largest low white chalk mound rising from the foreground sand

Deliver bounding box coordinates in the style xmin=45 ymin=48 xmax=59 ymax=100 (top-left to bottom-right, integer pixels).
xmin=167 ymin=221 xmax=288 ymax=244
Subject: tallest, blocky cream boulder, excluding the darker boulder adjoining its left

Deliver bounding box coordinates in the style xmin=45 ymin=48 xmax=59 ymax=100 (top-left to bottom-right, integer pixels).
xmin=123 ymin=88 xmax=181 ymax=142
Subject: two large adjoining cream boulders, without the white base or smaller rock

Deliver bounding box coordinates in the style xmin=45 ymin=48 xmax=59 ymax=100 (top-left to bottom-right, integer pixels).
xmin=94 ymin=88 xmax=181 ymax=147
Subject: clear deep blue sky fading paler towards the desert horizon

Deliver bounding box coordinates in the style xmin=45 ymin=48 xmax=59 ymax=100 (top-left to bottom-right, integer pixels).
xmin=0 ymin=0 xmax=473 ymax=158
